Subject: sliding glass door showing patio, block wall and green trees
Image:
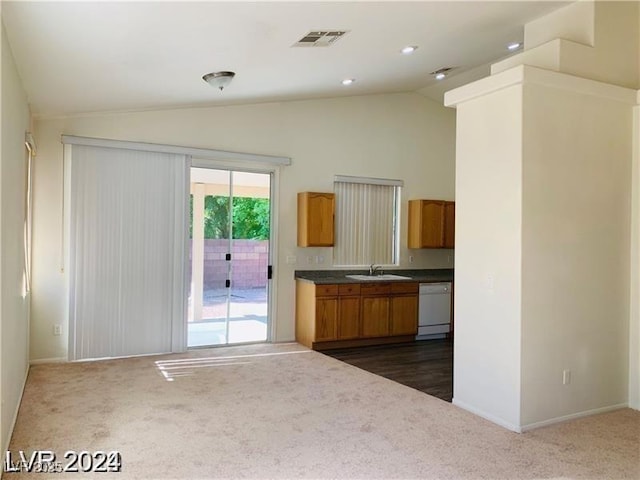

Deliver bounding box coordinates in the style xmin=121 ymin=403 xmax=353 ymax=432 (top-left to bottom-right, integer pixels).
xmin=188 ymin=168 xmax=271 ymax=347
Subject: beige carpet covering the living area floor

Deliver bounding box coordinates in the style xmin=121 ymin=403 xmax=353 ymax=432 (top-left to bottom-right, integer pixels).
xmin=3 ymin=344 xmax=640 ymax=480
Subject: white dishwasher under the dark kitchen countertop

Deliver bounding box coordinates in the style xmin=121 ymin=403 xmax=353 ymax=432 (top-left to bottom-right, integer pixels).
xmin=416 ymin=282 xmax=451 ymax=340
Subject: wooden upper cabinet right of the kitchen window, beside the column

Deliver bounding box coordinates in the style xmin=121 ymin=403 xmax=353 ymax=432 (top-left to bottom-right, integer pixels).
xmin=407 ymin=200 xmax=455 ymax=248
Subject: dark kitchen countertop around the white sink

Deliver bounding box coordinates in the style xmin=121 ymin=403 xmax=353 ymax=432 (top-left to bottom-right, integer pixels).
xmin=294 ymin=268 xmax=453 ymax=285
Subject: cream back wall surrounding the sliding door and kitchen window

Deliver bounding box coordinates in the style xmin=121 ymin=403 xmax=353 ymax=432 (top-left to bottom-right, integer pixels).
xmin=31 ymin=94 xmax=455 ymax=360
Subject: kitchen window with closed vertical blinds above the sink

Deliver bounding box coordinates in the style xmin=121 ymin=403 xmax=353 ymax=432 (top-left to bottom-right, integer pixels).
xmin=333 ymin=176 xmax=402 ymax=266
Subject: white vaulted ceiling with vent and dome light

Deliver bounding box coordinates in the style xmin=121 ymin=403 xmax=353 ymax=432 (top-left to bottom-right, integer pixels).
xmin=2 ymin=1 xmax=568 ymax=116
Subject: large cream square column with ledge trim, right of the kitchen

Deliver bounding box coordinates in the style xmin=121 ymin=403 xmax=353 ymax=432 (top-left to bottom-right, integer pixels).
xmin=445 ymin=65 xmax=637 ymax=431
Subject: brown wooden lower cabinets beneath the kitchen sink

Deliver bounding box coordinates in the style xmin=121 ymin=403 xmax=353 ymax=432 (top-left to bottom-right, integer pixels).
xmin=296 ymin=280 xmax=418 ymax=350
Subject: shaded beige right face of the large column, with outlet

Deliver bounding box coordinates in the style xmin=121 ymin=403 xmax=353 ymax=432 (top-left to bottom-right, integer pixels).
xmin=521 ymin=84 xmax=632 ymax=426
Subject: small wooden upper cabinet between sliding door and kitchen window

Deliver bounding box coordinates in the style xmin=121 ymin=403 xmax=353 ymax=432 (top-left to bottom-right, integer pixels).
xmin=298 ymin=192 xmax=335 ymax=247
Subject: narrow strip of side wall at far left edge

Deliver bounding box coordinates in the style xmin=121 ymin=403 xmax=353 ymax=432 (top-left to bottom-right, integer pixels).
xmin=0 ymin=16 xmax=29 ymax=451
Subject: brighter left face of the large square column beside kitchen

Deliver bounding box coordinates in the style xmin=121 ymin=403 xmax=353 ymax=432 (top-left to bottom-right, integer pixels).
xmin=453 ymin=86 xmax=522 ymax=430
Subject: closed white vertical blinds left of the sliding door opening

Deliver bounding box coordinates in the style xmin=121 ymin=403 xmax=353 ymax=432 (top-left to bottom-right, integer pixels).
xmin=70 ymin=145 xmax=187 ymax=359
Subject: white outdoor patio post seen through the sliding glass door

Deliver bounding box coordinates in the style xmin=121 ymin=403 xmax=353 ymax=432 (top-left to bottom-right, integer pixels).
xmin=191 ymin=183 xmax=205 ymax=321
